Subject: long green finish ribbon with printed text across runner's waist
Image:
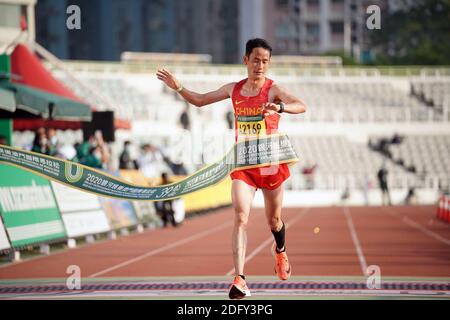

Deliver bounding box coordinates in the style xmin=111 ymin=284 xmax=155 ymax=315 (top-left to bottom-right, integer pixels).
xmin=0 ymin=134 xmax=298 ymax=201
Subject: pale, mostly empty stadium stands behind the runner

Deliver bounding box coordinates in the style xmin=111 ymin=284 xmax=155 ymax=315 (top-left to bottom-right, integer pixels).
xmin=10 ymin=63 xmax=450 ymax=189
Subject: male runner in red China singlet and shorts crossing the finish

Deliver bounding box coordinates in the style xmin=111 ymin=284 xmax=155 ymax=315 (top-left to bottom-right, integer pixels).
xmin=157 ymin=38 xmax=306 ymax=299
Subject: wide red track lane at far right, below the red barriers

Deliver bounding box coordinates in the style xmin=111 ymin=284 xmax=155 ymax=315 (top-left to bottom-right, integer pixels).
xmin=351 ymin=207 xmax=450 ymax=277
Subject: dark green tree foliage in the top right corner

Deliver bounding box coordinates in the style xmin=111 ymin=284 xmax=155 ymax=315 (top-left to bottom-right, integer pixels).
xmin=370 ymin=0 xmax=450 ymax=65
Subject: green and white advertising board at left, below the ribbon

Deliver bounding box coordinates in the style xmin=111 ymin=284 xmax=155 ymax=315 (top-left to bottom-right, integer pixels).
xmin=0 ymin=164 xmax=66 ymax=248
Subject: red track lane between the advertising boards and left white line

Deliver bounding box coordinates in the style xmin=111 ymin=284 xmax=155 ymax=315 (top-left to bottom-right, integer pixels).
xmin=0 ymin=209 xmax=233 ymax=279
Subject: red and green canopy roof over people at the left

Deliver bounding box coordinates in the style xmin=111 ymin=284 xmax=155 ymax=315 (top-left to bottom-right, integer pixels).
xmin=0 ymin=44 xmax=131 ymax=130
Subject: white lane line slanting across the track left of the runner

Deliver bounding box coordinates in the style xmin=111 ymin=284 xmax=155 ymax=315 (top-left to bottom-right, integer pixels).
xmin=88 ymin=221 xmax=233 ymax=278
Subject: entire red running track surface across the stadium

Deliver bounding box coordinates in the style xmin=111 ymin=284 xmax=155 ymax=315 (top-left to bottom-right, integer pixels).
xmin=0 ymin=207 xmax=450 ymax=279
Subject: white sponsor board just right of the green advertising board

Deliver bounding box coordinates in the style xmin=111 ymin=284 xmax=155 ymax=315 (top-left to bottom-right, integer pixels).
xmin=51 ymin=181 xmax=110 ymax=237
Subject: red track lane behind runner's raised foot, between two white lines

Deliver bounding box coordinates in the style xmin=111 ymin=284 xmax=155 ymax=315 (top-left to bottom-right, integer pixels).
xmin=246 ymin=207 xmax=362 ymax=276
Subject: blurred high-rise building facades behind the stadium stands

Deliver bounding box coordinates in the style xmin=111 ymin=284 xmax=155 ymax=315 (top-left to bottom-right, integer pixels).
xmin=32 ymin=0 xmax=390 ymax=63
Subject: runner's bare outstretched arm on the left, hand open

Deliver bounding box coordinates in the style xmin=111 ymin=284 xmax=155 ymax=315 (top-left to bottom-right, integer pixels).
xmin=156 ymin=69 xmax=234 ymax=107
